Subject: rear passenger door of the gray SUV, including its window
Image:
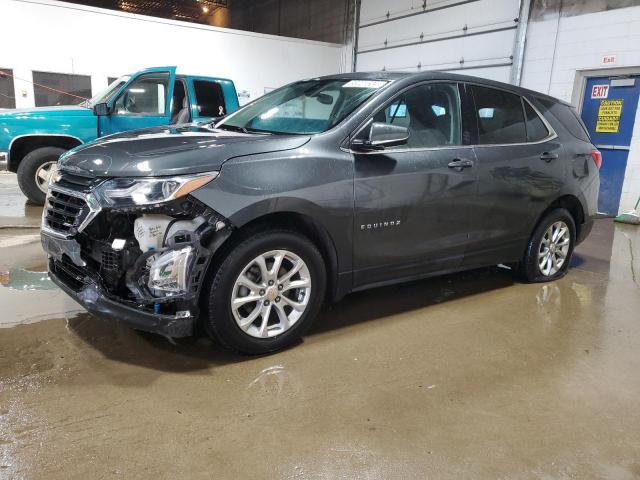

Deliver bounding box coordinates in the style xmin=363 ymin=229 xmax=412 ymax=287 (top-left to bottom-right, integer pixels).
xmin=465 ymin=85 xmax=565 ymax=266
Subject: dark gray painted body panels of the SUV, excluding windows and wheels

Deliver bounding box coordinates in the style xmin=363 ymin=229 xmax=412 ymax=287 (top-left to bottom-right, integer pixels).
xmin=62 ymin=72 xmax=598 ymax=295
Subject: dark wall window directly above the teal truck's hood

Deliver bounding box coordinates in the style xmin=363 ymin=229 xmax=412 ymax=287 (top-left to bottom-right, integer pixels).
xmin=33 ymin=72 xmax=91 ymax=107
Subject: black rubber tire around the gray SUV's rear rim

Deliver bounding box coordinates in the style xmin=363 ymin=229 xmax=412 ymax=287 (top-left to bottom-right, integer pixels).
xmin=517 ymin=208 xmax=576 ymax=283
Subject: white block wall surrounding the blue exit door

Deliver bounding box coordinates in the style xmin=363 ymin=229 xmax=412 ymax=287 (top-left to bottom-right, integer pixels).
xmin=522 ymin=6 xmax=640 ymax=211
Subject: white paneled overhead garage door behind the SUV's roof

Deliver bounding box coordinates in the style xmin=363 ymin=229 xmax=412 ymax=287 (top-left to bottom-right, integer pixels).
xmin=357 ymin=0 xmax=519 ymax=82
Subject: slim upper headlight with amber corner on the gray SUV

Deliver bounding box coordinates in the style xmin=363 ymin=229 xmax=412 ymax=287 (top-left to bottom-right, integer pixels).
xmin=97 ymin=172 xmax=218 ymax=207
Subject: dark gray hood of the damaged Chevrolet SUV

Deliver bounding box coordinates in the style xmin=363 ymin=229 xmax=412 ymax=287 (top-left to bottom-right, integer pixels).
xmin=60 ymin=124 xmax=310 ymax=177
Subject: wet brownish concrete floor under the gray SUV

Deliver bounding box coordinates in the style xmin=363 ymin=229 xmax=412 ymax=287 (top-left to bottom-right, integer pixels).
xmin=0 ymin=175 xmax=640 ymax=480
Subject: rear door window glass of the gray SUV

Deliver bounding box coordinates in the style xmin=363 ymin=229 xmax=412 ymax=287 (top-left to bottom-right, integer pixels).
xmin=471 ymin=85 xmax=527 ymax=145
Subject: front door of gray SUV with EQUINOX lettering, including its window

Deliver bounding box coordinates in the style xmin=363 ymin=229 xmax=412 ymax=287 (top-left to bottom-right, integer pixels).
xmin=354 ymin=83 xmax=476 ymax=287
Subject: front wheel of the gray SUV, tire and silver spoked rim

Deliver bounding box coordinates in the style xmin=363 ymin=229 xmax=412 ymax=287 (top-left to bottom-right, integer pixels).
xmin=201 ymin=229 xmax=326 ymax=355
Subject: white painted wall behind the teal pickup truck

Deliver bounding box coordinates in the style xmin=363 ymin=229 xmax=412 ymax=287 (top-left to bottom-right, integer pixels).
xmin=0 ymin=0 xmax=350 ymax=108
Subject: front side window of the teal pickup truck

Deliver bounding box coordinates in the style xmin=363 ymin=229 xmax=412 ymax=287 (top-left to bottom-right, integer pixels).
xmin=114 ymin=72 xmax=170 ymax=115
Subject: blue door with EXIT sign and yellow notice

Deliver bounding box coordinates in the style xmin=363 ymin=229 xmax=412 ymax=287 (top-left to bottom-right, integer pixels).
xmin=582 ymin=76 xmax=640 ymax=215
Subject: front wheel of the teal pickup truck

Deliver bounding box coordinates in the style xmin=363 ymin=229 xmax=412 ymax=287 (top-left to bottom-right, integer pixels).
xmin=18 ymin=147 xmax=65 ymax=205
